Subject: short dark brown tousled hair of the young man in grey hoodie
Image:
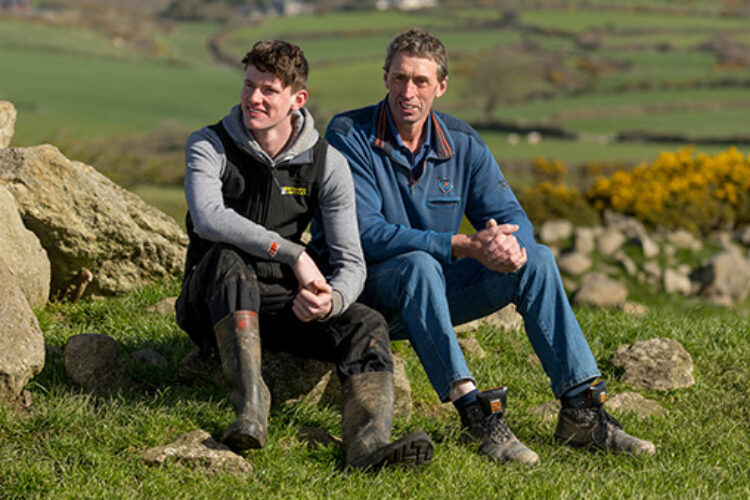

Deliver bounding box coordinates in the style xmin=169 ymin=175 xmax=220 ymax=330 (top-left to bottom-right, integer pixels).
xmin=242 ymin=40 xmax=309 ymax=92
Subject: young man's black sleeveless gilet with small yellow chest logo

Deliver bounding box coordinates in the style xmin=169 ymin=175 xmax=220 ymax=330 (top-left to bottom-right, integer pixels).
xmin=185 ymin=122 xmax=327 ymax=278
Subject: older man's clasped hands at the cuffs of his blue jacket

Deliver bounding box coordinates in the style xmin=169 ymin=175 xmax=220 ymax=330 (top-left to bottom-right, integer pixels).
xmin=451 ymin=219 xmax=526 ymax=273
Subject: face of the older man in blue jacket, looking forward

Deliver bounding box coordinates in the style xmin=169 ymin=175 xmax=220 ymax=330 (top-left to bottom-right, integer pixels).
xmin=383 ymin=52 xmax=448 ymax=131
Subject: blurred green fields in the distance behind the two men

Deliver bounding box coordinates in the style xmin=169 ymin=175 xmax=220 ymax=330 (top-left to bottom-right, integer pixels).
xmin=0 ymin=0 xmax=750 ymax=206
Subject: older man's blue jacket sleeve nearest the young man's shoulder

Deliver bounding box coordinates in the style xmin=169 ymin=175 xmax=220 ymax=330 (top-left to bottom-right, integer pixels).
xmin=326 ymin=122 xmax=453 ymax=262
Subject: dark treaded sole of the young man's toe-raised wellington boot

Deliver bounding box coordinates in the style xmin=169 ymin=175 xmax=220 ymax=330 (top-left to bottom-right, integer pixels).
xmin=351 ymin=431 xmax=435 ymax=471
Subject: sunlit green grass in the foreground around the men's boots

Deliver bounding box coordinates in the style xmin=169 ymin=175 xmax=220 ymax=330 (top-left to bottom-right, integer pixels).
xmin=0 ymin=283 xmax=750 ymax=499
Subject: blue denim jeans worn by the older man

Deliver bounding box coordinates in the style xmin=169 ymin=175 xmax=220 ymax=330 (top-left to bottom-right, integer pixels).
xmin=359 ymin=244 xmax=601 ymax=401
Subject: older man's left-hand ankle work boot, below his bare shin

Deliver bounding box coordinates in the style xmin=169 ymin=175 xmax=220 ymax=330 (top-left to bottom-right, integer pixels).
xmin=458 ymin=386 xmax=539 ymax=465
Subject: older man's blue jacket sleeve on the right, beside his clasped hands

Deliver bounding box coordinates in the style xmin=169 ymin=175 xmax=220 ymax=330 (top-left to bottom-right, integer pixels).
xmin=466 ymin=145 xmax=535 ymax=247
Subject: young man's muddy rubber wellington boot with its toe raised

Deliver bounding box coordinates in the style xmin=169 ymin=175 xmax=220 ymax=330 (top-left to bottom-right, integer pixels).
xmin=341 ymin=372 xmax=434 ymax=470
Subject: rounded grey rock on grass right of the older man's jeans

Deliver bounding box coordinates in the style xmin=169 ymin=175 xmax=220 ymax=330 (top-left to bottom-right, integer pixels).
xmin=611 ymin=338 xmax=695 ymax=391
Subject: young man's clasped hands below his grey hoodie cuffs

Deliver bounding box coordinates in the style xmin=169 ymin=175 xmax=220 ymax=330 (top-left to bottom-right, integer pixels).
xmin=292 ymin=252 xmax=333 ymax=321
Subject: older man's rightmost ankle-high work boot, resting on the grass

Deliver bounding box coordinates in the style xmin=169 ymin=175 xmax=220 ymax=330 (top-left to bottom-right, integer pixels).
xmin=555 ymin=381 xmax=656 ymax=455
